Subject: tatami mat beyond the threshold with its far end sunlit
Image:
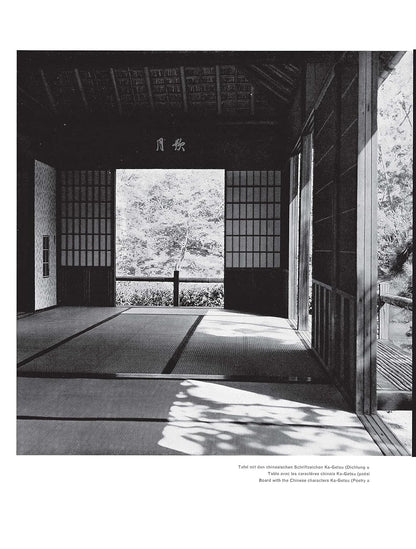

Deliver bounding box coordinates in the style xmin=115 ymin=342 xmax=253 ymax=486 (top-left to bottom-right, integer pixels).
xmin=174 ymin=313 xmax=324 ymax=378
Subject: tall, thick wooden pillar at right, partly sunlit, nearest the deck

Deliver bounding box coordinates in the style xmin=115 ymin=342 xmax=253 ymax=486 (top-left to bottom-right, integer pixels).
xmin=356 ymin=52 xmax=378 ymax=414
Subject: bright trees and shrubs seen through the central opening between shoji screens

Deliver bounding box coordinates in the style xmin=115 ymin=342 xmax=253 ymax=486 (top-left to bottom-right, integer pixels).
xmin=116 ymin=170 xmax=224 ymax=307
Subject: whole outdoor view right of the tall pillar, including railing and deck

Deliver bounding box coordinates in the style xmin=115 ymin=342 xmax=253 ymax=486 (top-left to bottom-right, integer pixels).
xmin=377 ymin=52 xmax=413 ymax=444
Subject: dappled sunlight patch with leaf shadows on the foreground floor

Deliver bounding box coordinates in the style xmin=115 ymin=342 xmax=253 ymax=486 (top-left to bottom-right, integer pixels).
xmin=158 ymin=380 xmax=380 ymax=456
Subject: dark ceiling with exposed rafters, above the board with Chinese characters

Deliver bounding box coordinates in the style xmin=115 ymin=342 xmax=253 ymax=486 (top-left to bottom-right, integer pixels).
xmin=17 ymin=51 xmax=400 ymax=134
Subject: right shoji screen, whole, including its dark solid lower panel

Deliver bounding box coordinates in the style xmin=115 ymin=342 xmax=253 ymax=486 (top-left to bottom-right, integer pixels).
xmin=224 ymin=170 xmax=287 ymax=316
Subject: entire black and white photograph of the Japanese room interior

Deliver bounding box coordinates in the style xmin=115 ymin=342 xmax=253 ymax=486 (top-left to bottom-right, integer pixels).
xmin=17 ymin=51 xmax=413 ymax=456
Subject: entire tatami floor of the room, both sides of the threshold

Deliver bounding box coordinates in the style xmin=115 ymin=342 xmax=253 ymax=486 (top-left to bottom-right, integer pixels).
xmin=17 ymin=308 xmax=386 ymax=455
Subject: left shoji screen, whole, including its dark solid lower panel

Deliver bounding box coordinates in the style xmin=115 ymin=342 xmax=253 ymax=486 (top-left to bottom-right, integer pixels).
xmin=58 ymin=170 xmax=114 ymax=306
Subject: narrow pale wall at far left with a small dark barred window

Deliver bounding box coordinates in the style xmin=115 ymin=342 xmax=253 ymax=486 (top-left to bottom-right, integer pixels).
xmin=34 ymin=160 xmax=57 ymax=310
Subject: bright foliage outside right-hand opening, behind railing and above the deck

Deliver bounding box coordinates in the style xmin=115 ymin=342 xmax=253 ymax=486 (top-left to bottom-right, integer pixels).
xmin=378 ymin=52 xmax=413 ymax=352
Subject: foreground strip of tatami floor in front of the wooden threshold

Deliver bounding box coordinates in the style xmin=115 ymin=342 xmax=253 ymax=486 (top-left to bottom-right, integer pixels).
xmin=17 ymin=378 xmax=380 ymax=455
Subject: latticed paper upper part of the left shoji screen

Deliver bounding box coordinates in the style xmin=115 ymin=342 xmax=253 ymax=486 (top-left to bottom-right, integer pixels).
xmin=61 ymin=170 xmax=113 ymax=267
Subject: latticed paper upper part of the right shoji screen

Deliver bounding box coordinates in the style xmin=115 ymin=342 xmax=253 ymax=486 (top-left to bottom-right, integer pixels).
xmin=225 ymin=171 xmax=281 ymax=269
